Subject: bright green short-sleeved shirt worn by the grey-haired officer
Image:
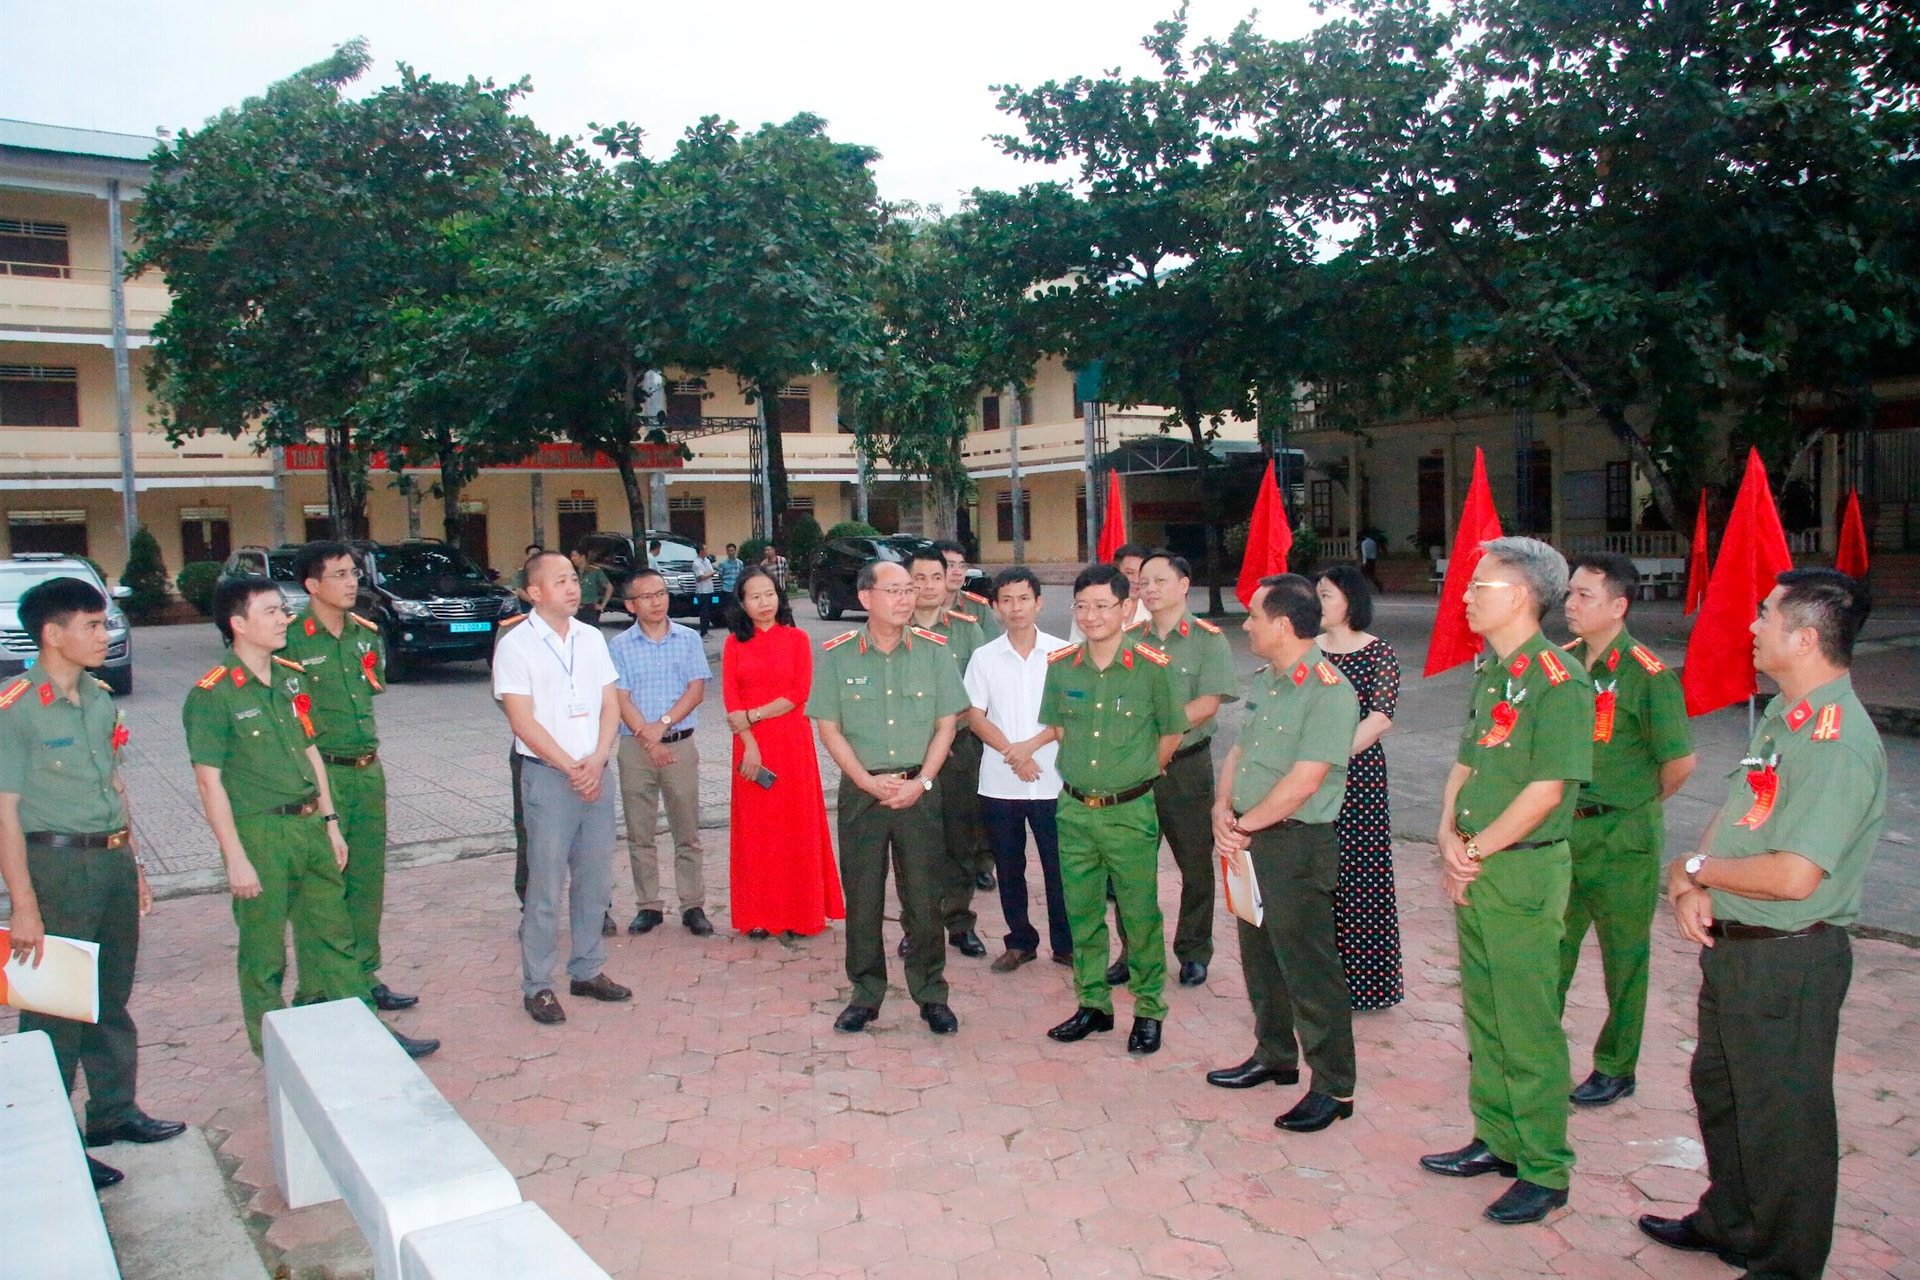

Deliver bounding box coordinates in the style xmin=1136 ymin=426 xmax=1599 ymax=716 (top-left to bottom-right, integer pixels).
xmin=1453 ymin=631 xmax=1594 ymax=841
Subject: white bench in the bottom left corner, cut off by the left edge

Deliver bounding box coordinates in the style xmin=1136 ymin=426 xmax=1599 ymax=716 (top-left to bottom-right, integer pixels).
xmin=0 ymin=1031 xmax=119 ymax=1280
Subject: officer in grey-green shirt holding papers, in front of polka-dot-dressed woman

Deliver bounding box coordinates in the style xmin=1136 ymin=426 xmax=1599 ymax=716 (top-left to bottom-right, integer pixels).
xmin=1205 ymin=579 xmax=1359 ymax=1134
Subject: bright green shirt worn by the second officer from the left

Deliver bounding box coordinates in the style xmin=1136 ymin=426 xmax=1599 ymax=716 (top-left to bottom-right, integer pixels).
xmin=180 ymin=649 xmax=321 ymax=818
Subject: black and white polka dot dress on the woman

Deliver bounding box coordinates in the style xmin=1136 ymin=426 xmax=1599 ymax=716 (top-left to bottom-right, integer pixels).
xmin=1327 ymin=639 xmax=1405 ymax=1009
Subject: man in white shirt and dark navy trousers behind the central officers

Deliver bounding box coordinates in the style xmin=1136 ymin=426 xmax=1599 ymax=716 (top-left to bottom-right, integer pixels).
xmin=964 ymin=566 xmax=1073 ymax=973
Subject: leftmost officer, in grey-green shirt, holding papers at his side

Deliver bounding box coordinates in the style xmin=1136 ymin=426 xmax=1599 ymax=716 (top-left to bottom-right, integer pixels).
xmin=0 ymin=578 xmax=186 ymax=1186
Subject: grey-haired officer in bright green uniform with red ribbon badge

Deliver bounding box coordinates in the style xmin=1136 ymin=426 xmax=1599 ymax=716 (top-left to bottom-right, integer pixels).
xmin=1421 ymin=537 xmax=1594 ymax=1224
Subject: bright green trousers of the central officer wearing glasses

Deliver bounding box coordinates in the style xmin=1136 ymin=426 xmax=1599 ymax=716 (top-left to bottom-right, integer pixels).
xmin=1058 ymin=794 xmax=1167 ymax=1019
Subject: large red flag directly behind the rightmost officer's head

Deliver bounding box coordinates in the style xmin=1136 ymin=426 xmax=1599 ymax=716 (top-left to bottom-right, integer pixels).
xmin=1680 ymin=449 xmax=1793 ymax=716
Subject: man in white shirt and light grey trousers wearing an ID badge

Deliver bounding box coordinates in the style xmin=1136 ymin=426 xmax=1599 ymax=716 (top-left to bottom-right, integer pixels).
xmin=493 ymin=551 xmax=634 ymax=1023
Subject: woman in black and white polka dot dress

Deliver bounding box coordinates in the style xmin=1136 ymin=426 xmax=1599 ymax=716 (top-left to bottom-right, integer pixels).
xmin=1317 ymin=564 xmax=1405 ymax=1009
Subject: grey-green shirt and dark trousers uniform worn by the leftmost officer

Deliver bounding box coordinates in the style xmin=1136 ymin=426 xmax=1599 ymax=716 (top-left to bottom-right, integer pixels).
xmin=0 ymin=662 xmax=140 ymax=1130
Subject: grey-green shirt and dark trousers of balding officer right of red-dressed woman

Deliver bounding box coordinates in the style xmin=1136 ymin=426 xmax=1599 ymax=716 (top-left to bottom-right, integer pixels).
xmin=806 ymin=628 xmax=968 ymax=1009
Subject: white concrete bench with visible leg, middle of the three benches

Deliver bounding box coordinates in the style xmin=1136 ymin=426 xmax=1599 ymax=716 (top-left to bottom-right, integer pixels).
xmin=263 ymin=1000 xmax=520 ymax=1280
